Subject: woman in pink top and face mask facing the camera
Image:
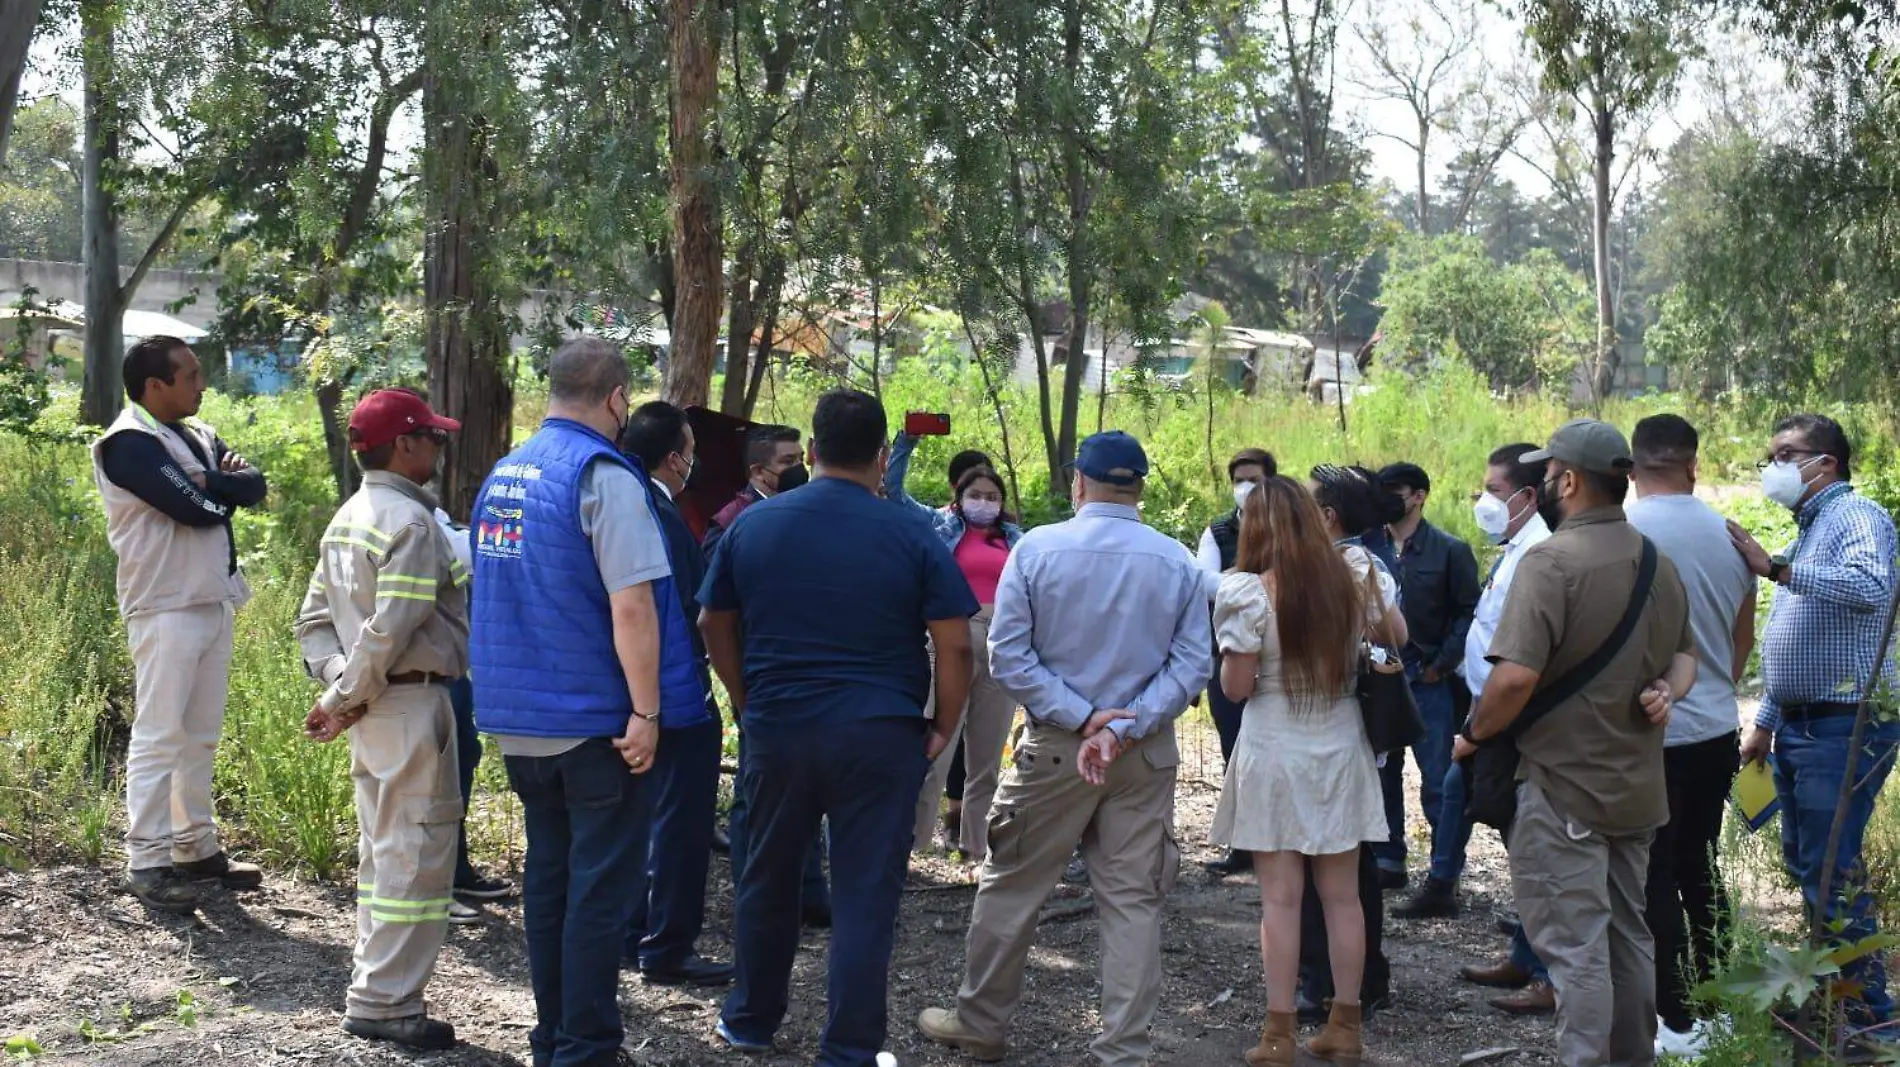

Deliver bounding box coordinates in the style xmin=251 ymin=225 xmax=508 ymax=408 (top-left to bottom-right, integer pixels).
xmin=912 ymin=465 xmax=1022 ymax=864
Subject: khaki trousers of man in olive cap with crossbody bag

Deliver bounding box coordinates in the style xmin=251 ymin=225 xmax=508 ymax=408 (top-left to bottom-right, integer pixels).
xmin=1511 ymin=780 xmax=1657 ymax=1067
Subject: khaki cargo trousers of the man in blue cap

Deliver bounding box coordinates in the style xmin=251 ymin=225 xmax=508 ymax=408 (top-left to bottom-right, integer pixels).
xmin=958 ymin=721 xmax=1180 ymax=1067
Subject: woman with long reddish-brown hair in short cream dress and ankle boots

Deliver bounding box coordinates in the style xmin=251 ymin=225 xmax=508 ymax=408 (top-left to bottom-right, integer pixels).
xmin=1214 ymin=477 xmax=1404 ymax=1067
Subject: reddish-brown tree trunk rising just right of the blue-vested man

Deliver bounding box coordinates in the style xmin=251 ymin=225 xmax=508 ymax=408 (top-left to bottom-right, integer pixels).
xmin=659 ymin=0 xmax=724 ymax=408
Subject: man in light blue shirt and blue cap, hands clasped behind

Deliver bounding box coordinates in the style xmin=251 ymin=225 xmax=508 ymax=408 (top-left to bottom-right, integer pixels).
xmin=918 ymin=431 xmax=1214 ymax=1067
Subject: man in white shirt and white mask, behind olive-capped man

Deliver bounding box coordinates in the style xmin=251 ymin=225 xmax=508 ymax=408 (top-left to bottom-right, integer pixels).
xmin=1393 ymin=444 xmax=1556 ymax=1016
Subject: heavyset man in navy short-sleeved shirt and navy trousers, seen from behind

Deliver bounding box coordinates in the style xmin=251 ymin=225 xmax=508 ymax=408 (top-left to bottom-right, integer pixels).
xmin=699 ymin=389 xmax=977 ymax=1067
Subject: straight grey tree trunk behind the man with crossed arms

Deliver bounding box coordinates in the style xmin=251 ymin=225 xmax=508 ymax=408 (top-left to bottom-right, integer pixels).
xmin=80 ymin=0 xmax=125 ymax=425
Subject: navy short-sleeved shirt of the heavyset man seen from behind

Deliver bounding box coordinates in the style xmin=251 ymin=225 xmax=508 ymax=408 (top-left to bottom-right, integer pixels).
xmin=699 ymin=478 xmax=979 ymax=731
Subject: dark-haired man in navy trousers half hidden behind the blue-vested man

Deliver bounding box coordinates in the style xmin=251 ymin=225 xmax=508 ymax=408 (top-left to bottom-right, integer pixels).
xmin=621 ymin=401 xmax=732 ymax=985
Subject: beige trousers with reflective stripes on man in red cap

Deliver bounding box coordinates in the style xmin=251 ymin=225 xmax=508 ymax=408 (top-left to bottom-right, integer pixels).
xmin=346 ymin=685 xmax=462 ymax=1020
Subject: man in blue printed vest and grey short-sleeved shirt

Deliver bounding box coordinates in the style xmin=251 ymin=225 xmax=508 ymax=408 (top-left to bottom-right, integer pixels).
xmin=469 ymin=338 xmax=705 ymax=1067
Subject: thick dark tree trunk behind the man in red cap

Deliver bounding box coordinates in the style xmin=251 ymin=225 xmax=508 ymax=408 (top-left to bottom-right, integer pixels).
xmin=422 ymin=57 xmax=515 ymax=520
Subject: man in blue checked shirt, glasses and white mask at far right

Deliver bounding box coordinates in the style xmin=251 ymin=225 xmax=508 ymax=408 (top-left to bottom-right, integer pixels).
xmin=1729 ymin=414 xmax=1900 ymax=1025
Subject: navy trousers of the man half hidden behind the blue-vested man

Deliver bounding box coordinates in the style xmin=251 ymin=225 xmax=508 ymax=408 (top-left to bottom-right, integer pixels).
xmin=625 ymin=718 xmax=720 ymax=970
